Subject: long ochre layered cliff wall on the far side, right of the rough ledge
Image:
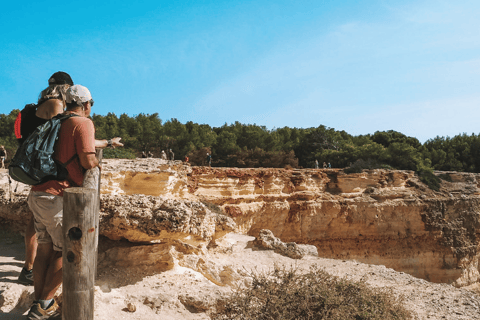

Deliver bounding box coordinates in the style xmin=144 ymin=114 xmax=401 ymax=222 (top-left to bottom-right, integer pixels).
xmin=189 ymin=168 xmax=480 ymax=286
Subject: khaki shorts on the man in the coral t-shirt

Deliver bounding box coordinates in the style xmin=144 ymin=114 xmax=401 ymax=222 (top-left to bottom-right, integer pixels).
xmin=27 ymin=191 xmax=63 ymax=251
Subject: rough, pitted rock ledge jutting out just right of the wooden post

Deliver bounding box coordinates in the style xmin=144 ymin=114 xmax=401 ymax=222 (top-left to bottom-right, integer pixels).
xmin=100 ymin=195 xmax=235 ymax=245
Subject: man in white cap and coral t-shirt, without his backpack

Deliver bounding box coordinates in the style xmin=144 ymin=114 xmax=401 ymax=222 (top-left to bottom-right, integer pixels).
xmin=27 ymin=85 xmax=119 ymax=320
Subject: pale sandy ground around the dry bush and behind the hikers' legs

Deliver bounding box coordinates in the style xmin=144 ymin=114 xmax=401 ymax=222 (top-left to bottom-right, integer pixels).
xmin=0 ymin=230 xmax=480 ymax=320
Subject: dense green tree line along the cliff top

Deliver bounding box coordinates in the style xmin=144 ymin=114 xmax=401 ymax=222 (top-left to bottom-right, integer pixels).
xmin=0 ymin=110 xmax=480 ymax=178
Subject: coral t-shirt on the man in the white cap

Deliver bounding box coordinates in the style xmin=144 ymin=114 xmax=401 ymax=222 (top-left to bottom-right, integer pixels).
xmin=32 ymin=117 xmax=95 ymax=196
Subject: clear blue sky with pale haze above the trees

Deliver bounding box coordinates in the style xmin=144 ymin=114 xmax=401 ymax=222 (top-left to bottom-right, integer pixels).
xmin=0 ymin=0 xmax=480 ymax=142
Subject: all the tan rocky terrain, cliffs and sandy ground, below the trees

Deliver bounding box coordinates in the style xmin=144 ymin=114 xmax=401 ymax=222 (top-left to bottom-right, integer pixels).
xmin=0 ymin=159 xmax=480 ymax=320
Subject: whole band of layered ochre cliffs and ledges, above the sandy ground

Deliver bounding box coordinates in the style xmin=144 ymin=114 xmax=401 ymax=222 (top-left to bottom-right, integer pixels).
xmin=0 ymin=159 xmax=480 ymax=286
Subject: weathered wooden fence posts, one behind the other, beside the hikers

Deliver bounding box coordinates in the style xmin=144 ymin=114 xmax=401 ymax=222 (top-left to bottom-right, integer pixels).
xmin=62 ymin=149 xmax=102 ymax=320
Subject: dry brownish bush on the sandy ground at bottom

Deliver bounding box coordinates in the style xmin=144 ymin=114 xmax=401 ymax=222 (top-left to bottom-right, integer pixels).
xmin=212 ymin=267 xmax=411 ymax=320
